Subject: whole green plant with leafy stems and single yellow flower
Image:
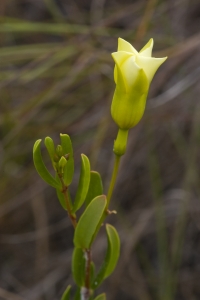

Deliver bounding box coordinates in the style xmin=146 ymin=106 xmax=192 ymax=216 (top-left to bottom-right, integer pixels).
xmin=33 ymin=39 xmax=166 ymax=300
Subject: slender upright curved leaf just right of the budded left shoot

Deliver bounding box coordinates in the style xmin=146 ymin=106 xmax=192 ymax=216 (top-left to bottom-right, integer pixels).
xmin=72 ymin=154 xmax=90 ymax=213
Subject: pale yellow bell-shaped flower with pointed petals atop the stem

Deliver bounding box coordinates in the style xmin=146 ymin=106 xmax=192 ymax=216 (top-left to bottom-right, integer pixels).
xmin=111 ymin=38 xmax=167 ymax=155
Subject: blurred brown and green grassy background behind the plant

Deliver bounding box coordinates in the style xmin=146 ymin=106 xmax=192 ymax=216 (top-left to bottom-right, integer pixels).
xmin=0 ymin=0 xmax=200 ymax=300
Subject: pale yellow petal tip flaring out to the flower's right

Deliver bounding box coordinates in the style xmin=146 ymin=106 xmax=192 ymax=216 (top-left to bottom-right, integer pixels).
xmin=136 ymin=55 xmax=167 ymax=84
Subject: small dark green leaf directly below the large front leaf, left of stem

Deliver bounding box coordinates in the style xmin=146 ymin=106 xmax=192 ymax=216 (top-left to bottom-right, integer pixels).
xmin=72 ymin=247 xmax=85 ymax=287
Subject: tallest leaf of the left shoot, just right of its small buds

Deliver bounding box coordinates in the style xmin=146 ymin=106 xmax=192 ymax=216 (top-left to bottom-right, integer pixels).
xmin=60 ymin=133 xmax=74 ymax=186
